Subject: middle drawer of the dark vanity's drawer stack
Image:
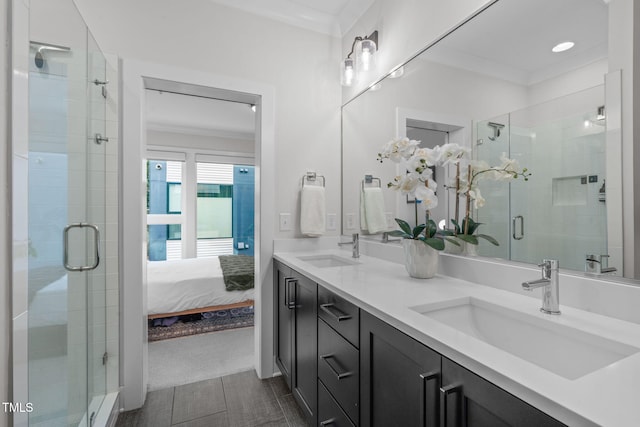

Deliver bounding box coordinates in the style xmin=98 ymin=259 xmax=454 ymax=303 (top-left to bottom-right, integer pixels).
xmin=318 ymin=320 xmax=360 ymax=424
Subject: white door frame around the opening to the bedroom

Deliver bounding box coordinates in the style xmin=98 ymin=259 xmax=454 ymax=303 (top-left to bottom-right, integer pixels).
xmin=119 ymin=60 xmax=275 ymax=410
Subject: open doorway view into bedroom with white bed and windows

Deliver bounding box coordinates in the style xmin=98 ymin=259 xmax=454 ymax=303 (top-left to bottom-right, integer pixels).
xmin=145 ymin=88 xmax=258 ymax=390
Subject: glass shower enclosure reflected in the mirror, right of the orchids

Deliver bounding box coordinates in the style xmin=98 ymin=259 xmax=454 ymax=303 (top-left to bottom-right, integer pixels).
xmin=475 ymin=86 xmax=608 ymax=270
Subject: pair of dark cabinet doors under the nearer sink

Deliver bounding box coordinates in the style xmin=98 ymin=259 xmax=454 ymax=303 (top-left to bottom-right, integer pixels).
xmin=360 ymin=312 xmax=564 ymax=427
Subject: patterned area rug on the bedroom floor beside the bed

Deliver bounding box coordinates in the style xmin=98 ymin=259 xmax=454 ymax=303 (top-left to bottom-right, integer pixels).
xmin=149 ymin=307 xmax=253 ymax=342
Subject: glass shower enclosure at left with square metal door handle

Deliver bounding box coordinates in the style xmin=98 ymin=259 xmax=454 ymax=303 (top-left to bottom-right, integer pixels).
xmin=28 ymin=0 xmax=108 ymax=426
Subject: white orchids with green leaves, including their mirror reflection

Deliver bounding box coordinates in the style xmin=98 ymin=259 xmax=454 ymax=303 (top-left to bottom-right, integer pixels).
xmin=378 ymin=137 xmax=531 ymax=249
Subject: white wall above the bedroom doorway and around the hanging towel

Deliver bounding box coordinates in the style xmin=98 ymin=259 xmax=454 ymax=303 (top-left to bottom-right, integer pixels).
xmin=76 ymin=0 xmax=340 ymax=241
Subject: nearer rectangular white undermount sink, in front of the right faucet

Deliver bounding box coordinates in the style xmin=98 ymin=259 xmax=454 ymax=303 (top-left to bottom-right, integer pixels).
xmin=410 ymin=297 xmax=640 ymax=380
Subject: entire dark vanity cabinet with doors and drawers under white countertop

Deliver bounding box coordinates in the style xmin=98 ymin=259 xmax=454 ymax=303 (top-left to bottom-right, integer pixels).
xmin=274 ymin=261 xmax=564 ymax=427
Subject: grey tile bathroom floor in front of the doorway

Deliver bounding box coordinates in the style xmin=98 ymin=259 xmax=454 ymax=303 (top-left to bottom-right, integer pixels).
xmin=116 ymin=370 xmax=316 ymax=427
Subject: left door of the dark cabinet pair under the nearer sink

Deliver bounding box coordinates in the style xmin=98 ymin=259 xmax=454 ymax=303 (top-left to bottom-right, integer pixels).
xmin=360 ymin=311 xmax=440 ymax=427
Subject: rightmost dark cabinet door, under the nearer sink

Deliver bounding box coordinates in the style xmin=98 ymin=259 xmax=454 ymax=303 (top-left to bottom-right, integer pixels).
xmin=440 ymin=357 xmax=564 ymax=427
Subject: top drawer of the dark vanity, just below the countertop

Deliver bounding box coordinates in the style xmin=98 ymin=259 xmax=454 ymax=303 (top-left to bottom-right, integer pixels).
xmin=318 ymin=286 xmax=360 ymax=347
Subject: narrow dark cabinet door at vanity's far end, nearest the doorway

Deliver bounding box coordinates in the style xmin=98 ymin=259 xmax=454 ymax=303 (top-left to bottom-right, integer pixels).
xmin=274 ymin=261 xmax=295 ymax=389
